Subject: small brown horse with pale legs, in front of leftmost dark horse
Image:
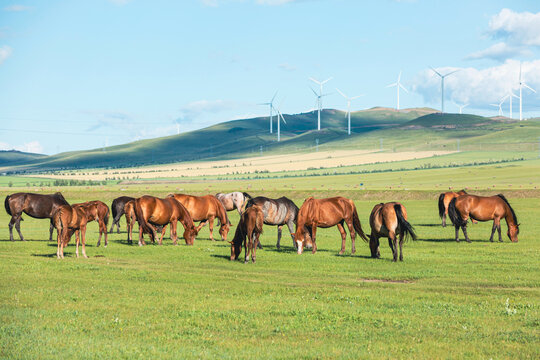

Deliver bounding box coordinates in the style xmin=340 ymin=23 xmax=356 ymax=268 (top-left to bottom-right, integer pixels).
xmin=52 ymin=205 xmax=88 ymax=259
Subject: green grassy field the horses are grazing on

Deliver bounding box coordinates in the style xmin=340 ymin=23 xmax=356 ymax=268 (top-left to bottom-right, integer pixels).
xmin=0 ymin=167 xmax=540 ymax=359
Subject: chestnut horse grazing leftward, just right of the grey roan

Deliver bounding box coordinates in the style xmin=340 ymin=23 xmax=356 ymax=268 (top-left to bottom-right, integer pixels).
xmin=294 ymin=196 xmax=367 ymax=254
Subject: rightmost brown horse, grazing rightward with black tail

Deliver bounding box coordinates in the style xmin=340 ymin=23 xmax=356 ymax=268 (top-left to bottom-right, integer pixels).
xmin=448 ymin=194 xmax=519 ymax=242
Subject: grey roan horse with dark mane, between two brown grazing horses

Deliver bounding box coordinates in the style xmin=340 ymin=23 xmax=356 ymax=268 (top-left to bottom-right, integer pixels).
xmin=246 ymin=196 xmax=298 ymax=249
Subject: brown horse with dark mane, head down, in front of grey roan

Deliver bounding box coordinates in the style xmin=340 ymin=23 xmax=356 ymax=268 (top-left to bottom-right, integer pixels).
xmin=230 ymin=206 xmax=264 ymax=264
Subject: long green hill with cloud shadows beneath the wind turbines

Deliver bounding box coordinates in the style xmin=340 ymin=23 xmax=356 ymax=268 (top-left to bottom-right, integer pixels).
xmin=2 ymin=108 xmax=540 ymax=171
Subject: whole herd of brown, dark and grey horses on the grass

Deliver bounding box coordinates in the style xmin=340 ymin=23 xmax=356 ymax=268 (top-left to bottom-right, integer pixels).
xmin=4 ymin=190 xmax=519 ymax=262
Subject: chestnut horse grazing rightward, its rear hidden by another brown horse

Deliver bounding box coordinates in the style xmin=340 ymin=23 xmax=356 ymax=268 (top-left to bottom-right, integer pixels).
xmin=169 ymin=194 xmax=231 ymax=241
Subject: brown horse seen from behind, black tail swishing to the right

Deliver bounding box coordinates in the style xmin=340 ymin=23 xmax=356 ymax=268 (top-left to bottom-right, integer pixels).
xmin=369 ymin=202 xmax=416 ymax=262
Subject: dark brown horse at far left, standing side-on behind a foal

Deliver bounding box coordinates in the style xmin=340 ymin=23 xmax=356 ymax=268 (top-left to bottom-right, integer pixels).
xmin=4 ymin=192 xmax=69 ymax=241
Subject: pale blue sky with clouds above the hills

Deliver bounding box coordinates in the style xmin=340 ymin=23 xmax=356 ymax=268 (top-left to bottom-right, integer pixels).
xmin=0 ymin=0 xmax=540 ymax=154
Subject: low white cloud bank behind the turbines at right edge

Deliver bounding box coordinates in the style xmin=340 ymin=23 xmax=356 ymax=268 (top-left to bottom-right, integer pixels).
xmin=412 ymin=60 xmax=540 ymax=110
